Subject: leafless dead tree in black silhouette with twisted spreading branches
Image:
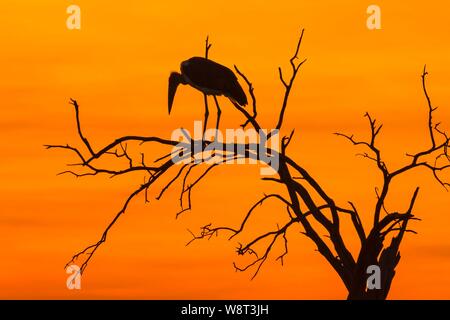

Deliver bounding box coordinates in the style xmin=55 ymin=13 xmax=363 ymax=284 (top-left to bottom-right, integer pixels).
xmin=46 ymin=30 xmax=450 ymax=299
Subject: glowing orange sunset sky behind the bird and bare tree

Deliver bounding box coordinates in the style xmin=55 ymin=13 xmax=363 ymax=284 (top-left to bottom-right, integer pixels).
xmin=0 ymin=0 xmax=450 ymax=299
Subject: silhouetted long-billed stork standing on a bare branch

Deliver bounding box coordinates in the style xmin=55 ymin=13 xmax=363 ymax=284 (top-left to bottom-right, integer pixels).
xmin=169 ymin=57 xmax=247 ymax=132
